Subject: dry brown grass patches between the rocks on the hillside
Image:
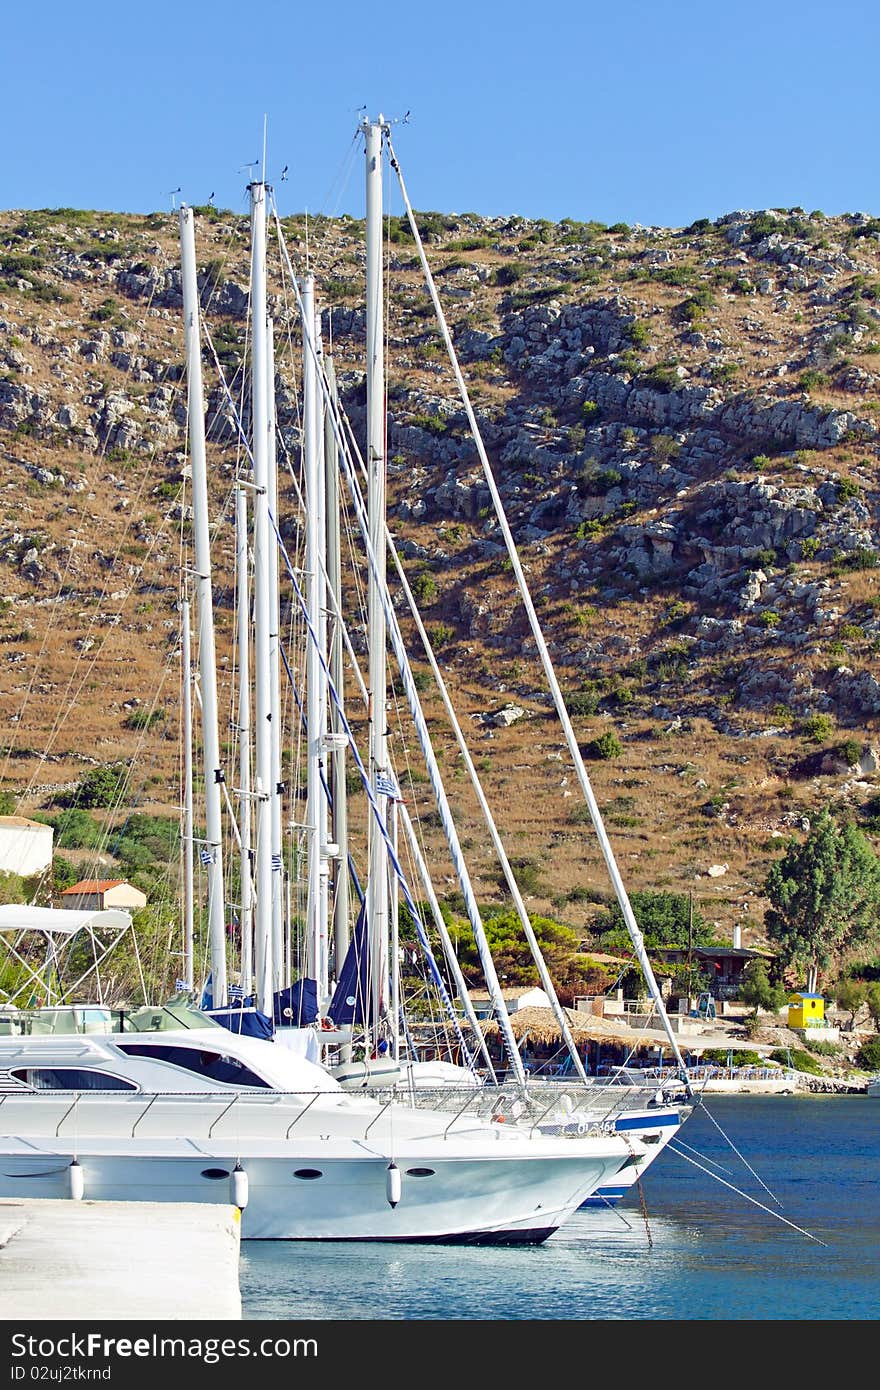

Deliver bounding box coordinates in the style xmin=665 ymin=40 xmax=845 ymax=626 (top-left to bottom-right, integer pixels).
xmin=0 ymin=202 xmax=880 ymax=956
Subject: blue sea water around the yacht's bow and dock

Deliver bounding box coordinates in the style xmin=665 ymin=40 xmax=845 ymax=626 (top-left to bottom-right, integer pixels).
xmin=241 ymin=1095 xmax=880 ymax=1323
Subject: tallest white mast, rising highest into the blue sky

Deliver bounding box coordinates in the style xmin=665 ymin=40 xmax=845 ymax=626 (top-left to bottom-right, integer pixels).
xmin=360 ymin=114 xmax=388 ymax=1039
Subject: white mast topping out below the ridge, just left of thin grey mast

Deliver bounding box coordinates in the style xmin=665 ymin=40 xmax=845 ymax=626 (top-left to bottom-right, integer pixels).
xmin=300 ymin=275 xmax=329 ymax=1008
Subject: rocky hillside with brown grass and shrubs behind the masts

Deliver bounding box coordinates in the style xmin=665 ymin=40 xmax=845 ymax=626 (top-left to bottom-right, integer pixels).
xmin=0 ymin=207 xmax=880 ymax=944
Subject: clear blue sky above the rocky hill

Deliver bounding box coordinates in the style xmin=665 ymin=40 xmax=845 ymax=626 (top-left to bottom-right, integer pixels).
xmin=0 ymin=0 xmax=880 ymax=227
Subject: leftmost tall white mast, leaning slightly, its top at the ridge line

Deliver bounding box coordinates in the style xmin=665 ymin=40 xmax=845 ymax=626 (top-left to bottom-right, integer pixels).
xmin=179 ymin=204 xmax=227 ymax=1008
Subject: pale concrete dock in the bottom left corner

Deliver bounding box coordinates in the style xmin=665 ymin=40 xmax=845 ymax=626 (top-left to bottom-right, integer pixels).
xmin=0 ymin=1198 xmax=242 ymax=1322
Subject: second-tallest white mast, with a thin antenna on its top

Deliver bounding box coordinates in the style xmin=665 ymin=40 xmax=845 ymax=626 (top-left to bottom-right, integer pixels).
xmin=249 ymin=182 xmax=277 ymax=1016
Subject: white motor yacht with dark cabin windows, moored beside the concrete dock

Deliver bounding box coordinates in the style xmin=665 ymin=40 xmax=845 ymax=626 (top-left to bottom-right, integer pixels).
xmin=0 ymin=999 xmax=631 ymax=1244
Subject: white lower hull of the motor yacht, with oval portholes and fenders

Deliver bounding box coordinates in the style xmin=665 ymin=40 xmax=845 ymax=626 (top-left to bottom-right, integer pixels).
xmin=0 ymin=1140 xmax=631 ymax=1244
